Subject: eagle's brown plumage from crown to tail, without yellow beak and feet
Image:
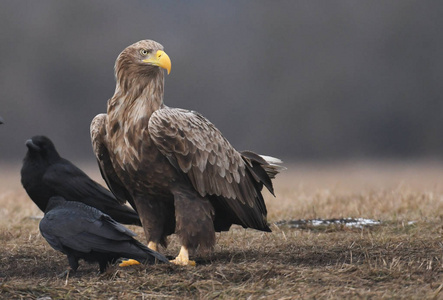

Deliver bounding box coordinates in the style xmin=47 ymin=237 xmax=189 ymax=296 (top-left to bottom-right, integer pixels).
xmin=91 ymin=40 xmax=281 ymax=254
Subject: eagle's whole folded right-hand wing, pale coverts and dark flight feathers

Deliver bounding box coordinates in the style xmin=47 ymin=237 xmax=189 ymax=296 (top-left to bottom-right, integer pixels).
xmin=148 ymin=108 xmax=266 ymax=227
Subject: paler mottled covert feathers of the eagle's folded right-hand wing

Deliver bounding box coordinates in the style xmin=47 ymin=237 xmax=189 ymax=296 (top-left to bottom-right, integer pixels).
xmin=149 ymin=108 xmax=245 ymax=201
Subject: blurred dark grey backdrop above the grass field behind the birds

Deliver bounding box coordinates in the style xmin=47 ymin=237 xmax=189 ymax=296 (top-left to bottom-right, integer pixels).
xmin=0 ymin=0 xmax=443 ymax=163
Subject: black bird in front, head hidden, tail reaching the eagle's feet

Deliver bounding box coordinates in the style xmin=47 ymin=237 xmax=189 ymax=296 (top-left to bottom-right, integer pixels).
xmin=40 ymin=196 xmax=169 ymax=273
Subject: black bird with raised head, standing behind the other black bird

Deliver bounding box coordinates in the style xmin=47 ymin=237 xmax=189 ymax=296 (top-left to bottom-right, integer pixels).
xmin=21 ymin=136 xmax=141 ymax=226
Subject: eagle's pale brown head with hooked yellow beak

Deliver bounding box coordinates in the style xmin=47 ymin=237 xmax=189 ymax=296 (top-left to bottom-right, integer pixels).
xmin=115 ymin=40 xmax=171 ymax=80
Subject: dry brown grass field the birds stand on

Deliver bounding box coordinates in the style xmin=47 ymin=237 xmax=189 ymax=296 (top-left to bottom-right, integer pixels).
xmin=0 ymin=162 xmax=443 ymax=299
